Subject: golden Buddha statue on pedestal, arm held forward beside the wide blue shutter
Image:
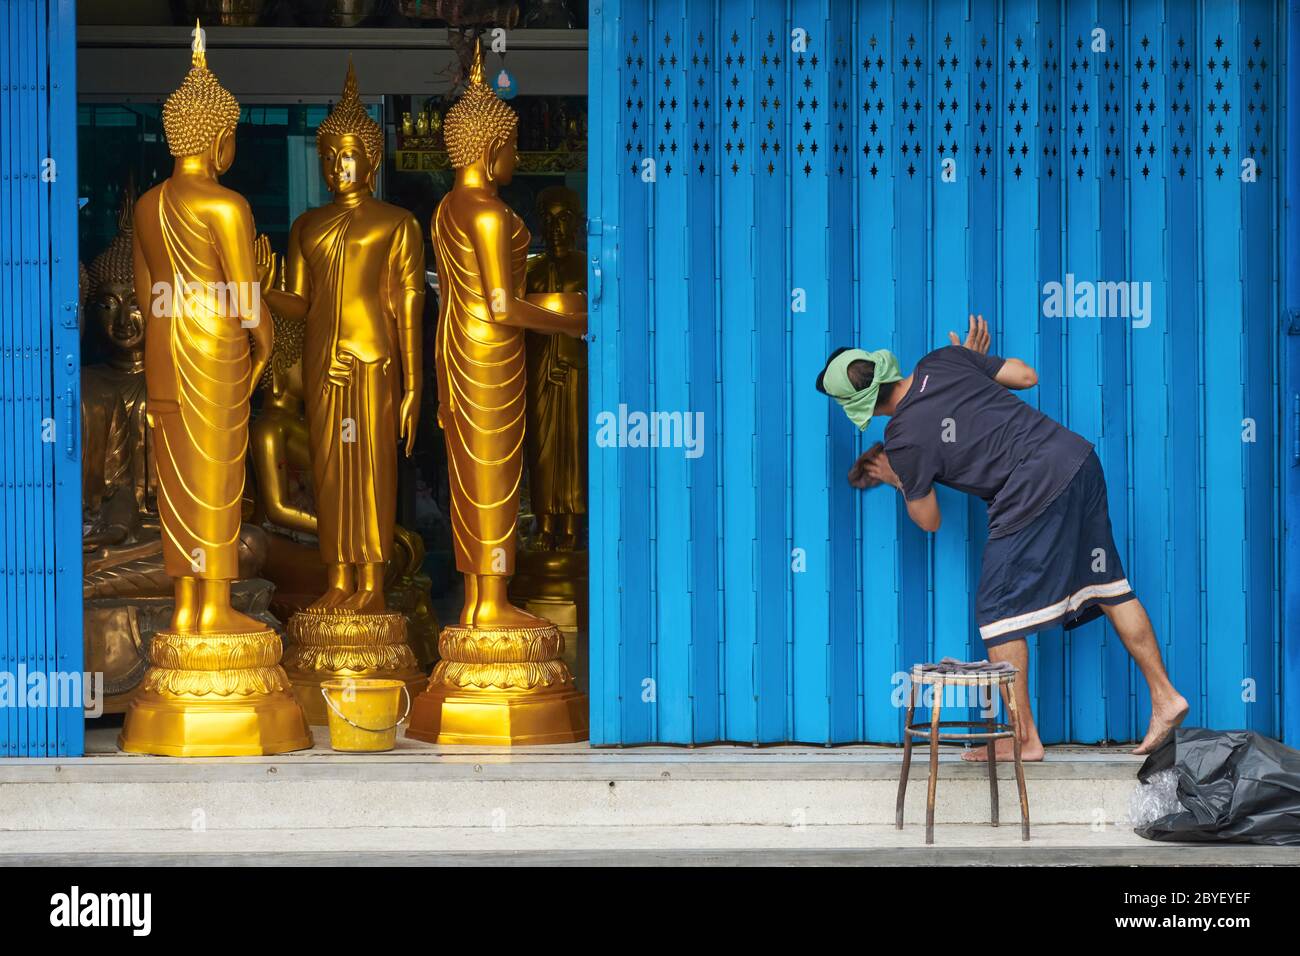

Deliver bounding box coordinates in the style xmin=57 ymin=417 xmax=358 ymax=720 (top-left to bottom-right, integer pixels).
xmin=407 ymin=43 xmax=588 ymax=744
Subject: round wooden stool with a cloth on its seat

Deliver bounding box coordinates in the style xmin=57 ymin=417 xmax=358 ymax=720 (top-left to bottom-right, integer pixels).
xmin=894 ymin=663 xmax=1030 ymax=843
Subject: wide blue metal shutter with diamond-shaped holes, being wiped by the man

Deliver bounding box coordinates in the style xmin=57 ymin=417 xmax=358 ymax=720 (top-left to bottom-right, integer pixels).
xmin=589 ymin=0 xmax=1297 ymax=744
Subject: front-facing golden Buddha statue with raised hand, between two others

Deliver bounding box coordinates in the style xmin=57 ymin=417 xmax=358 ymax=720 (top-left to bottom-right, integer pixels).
xmin=267 ymin=55 xmax=425 ymax=723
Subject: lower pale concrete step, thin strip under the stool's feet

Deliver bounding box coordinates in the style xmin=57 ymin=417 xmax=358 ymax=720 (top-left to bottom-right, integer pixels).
xmin=0 ymin=825 xmax=1300 ymax=866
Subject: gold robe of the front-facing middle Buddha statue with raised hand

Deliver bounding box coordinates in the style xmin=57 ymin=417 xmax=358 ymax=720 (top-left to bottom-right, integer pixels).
xmin=297 ymin=203 xmax=425 ymax=564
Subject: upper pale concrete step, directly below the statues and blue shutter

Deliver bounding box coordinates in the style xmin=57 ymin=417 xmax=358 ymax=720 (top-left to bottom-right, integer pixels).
xmin=0 ymin=735 xmax=1159 ymax=832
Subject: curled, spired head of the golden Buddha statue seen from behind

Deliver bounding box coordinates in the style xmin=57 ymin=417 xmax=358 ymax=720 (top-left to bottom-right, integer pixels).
xmin=163 ymin=23 xmax=239 ymax=176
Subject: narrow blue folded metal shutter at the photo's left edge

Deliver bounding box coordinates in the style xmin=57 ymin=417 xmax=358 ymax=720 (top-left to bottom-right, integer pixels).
xmin=0 ymin=0 xmax=83 ymax=757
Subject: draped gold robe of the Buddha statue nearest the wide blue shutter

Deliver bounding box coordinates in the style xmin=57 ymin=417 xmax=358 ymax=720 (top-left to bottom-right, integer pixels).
xmin=433 ymin=200 xmax=532 ymax=575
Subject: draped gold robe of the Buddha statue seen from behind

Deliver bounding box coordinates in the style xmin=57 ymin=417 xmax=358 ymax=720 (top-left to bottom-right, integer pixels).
xmin=144 ymin=179 xmax=252 ymax=580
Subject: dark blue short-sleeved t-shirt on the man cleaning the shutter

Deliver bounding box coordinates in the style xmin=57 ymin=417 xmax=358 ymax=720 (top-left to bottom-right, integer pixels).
xmin=885 ymin=345 xmax=1092 ymax=537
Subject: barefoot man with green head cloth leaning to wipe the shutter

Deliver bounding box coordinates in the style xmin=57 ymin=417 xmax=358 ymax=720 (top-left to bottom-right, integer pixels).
xmin=816 ymin=316 xmax=1187 ymax=760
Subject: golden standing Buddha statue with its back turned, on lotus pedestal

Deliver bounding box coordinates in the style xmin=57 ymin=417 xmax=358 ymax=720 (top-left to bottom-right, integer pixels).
xmin=118 ymin=25 xmax=311 ymax=757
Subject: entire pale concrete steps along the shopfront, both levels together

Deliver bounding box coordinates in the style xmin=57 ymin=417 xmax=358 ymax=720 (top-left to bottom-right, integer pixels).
xmin=0 ymin=730 xmax=1300 ymax=866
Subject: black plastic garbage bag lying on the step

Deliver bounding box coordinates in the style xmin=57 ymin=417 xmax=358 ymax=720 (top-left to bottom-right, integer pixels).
xmin=1135 ymin=727 xmax=1300 ymax=847
